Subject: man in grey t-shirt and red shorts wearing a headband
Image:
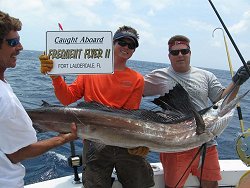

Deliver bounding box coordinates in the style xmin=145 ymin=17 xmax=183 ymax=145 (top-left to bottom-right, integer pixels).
xmin=144 ymin=35 xmax=250 ymax=187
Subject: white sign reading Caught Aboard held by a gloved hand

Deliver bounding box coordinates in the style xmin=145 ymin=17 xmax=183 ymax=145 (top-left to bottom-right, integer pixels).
xmin=46 ymin=31 xmax=114 ymax=75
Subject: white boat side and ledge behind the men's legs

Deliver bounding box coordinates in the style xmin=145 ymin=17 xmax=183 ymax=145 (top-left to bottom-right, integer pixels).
xmin=25 ymin=160 xmax=250 ymax=188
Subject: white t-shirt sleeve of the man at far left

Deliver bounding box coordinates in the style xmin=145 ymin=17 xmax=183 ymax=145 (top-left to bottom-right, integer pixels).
xmin=0 ymin=90 xmax=37 ymax=154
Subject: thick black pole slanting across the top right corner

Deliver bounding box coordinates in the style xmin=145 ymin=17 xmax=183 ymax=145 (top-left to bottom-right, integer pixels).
xmin=208 ymin=0 xmax=250 ymax=76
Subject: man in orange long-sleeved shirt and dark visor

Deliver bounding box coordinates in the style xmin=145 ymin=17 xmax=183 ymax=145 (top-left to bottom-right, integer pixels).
xmin=40 ymin=26 xmax=154 ymax=188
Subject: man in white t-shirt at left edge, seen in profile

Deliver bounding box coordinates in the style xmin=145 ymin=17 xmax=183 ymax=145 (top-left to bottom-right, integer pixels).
xmin=0 ymin=11 xmax=77 ymax=188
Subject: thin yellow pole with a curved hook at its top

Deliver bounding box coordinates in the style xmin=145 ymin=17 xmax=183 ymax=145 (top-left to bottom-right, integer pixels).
xmin=212 ymin=27 xmax=245 ymax=133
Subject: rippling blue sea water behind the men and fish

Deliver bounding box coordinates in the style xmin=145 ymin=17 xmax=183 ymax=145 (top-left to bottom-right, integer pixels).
xmin=5 ymin=51 xmax=250 ymax=184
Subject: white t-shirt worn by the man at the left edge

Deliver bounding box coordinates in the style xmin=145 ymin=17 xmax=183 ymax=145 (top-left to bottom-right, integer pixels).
xmin=0 ymin=80 xmax=37 ymax=188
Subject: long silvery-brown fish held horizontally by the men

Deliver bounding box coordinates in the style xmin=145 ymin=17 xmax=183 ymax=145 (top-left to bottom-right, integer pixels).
xmin=27 ymin=84 xmax=248 ymax=152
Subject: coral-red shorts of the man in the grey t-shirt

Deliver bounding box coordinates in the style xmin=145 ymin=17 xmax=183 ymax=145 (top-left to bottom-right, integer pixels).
xmin=160 ymin=146 xmax=221 ymax=187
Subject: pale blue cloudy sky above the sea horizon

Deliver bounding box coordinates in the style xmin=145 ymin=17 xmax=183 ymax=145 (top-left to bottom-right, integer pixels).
xmin=0 ymin=0 xmax=250 ymax=71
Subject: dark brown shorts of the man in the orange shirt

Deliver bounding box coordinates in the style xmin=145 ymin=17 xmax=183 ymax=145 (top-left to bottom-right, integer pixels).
xmin=83 ymin=142 xmax=154 ymax=188
